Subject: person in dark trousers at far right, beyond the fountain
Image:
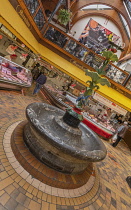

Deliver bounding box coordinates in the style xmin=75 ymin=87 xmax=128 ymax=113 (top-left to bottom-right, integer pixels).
xmin=112 ymin=122 xmax=128 ymax=147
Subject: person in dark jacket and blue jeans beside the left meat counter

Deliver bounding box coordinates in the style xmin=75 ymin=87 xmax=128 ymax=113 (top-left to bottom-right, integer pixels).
xmin=33 ymin=74 xmax=47 ymax=95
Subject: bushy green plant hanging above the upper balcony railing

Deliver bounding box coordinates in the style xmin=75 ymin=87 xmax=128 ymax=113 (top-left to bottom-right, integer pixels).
xmin=58 ymin=9 xmax=71 ymax=25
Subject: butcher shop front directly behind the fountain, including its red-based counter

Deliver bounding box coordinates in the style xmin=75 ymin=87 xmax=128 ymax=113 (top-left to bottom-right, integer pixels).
xmin=34 ymin=60 xmax=131 ymax=140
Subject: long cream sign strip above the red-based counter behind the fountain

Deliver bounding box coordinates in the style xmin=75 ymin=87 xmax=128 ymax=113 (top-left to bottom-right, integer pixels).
xmin=93 ymin=93 xmax=127 ymax=116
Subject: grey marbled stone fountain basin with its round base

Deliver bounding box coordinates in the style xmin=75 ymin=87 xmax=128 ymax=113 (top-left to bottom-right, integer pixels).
xmin=24 ymin=103 xmax=107 ymax=174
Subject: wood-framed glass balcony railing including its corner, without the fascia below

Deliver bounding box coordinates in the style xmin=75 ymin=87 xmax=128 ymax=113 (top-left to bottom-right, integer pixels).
xmin=10 ymin=0 xmax=131 ymax=94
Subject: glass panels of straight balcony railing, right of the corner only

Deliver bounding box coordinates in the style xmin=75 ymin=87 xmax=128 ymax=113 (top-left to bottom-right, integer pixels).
xmin=44 ymin=24 xmax=129 ymax=85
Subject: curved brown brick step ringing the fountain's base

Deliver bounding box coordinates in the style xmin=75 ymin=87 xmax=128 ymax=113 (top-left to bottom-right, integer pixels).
xmin=11 ymin=120 xmax=95 ymax=191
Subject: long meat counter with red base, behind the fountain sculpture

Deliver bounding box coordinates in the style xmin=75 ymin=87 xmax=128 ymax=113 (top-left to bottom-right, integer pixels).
xmin=41 ymin=85 xmax=115 ymax=140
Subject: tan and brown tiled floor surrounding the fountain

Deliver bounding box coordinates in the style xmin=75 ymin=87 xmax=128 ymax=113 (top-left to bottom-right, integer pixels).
xmin=0 ymin=90 xmax=131 ymax=210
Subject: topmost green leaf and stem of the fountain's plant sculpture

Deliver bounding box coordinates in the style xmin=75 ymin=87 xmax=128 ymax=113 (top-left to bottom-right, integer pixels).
xmin=97 ymin=50 xmax=118 ymax=75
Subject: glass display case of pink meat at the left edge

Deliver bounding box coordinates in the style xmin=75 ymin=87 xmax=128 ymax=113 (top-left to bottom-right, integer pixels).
xmin=0 ymin=56 xmax=32 ymax=87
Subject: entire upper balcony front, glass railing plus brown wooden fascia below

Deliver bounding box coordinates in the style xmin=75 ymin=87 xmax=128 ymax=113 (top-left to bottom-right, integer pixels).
xmin=10 ymin=0 xmax=131 ymax=98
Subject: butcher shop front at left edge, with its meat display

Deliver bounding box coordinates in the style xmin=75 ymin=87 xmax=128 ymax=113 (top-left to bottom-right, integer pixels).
xmin=0 ymin=23 xmax=34 ymax=91
